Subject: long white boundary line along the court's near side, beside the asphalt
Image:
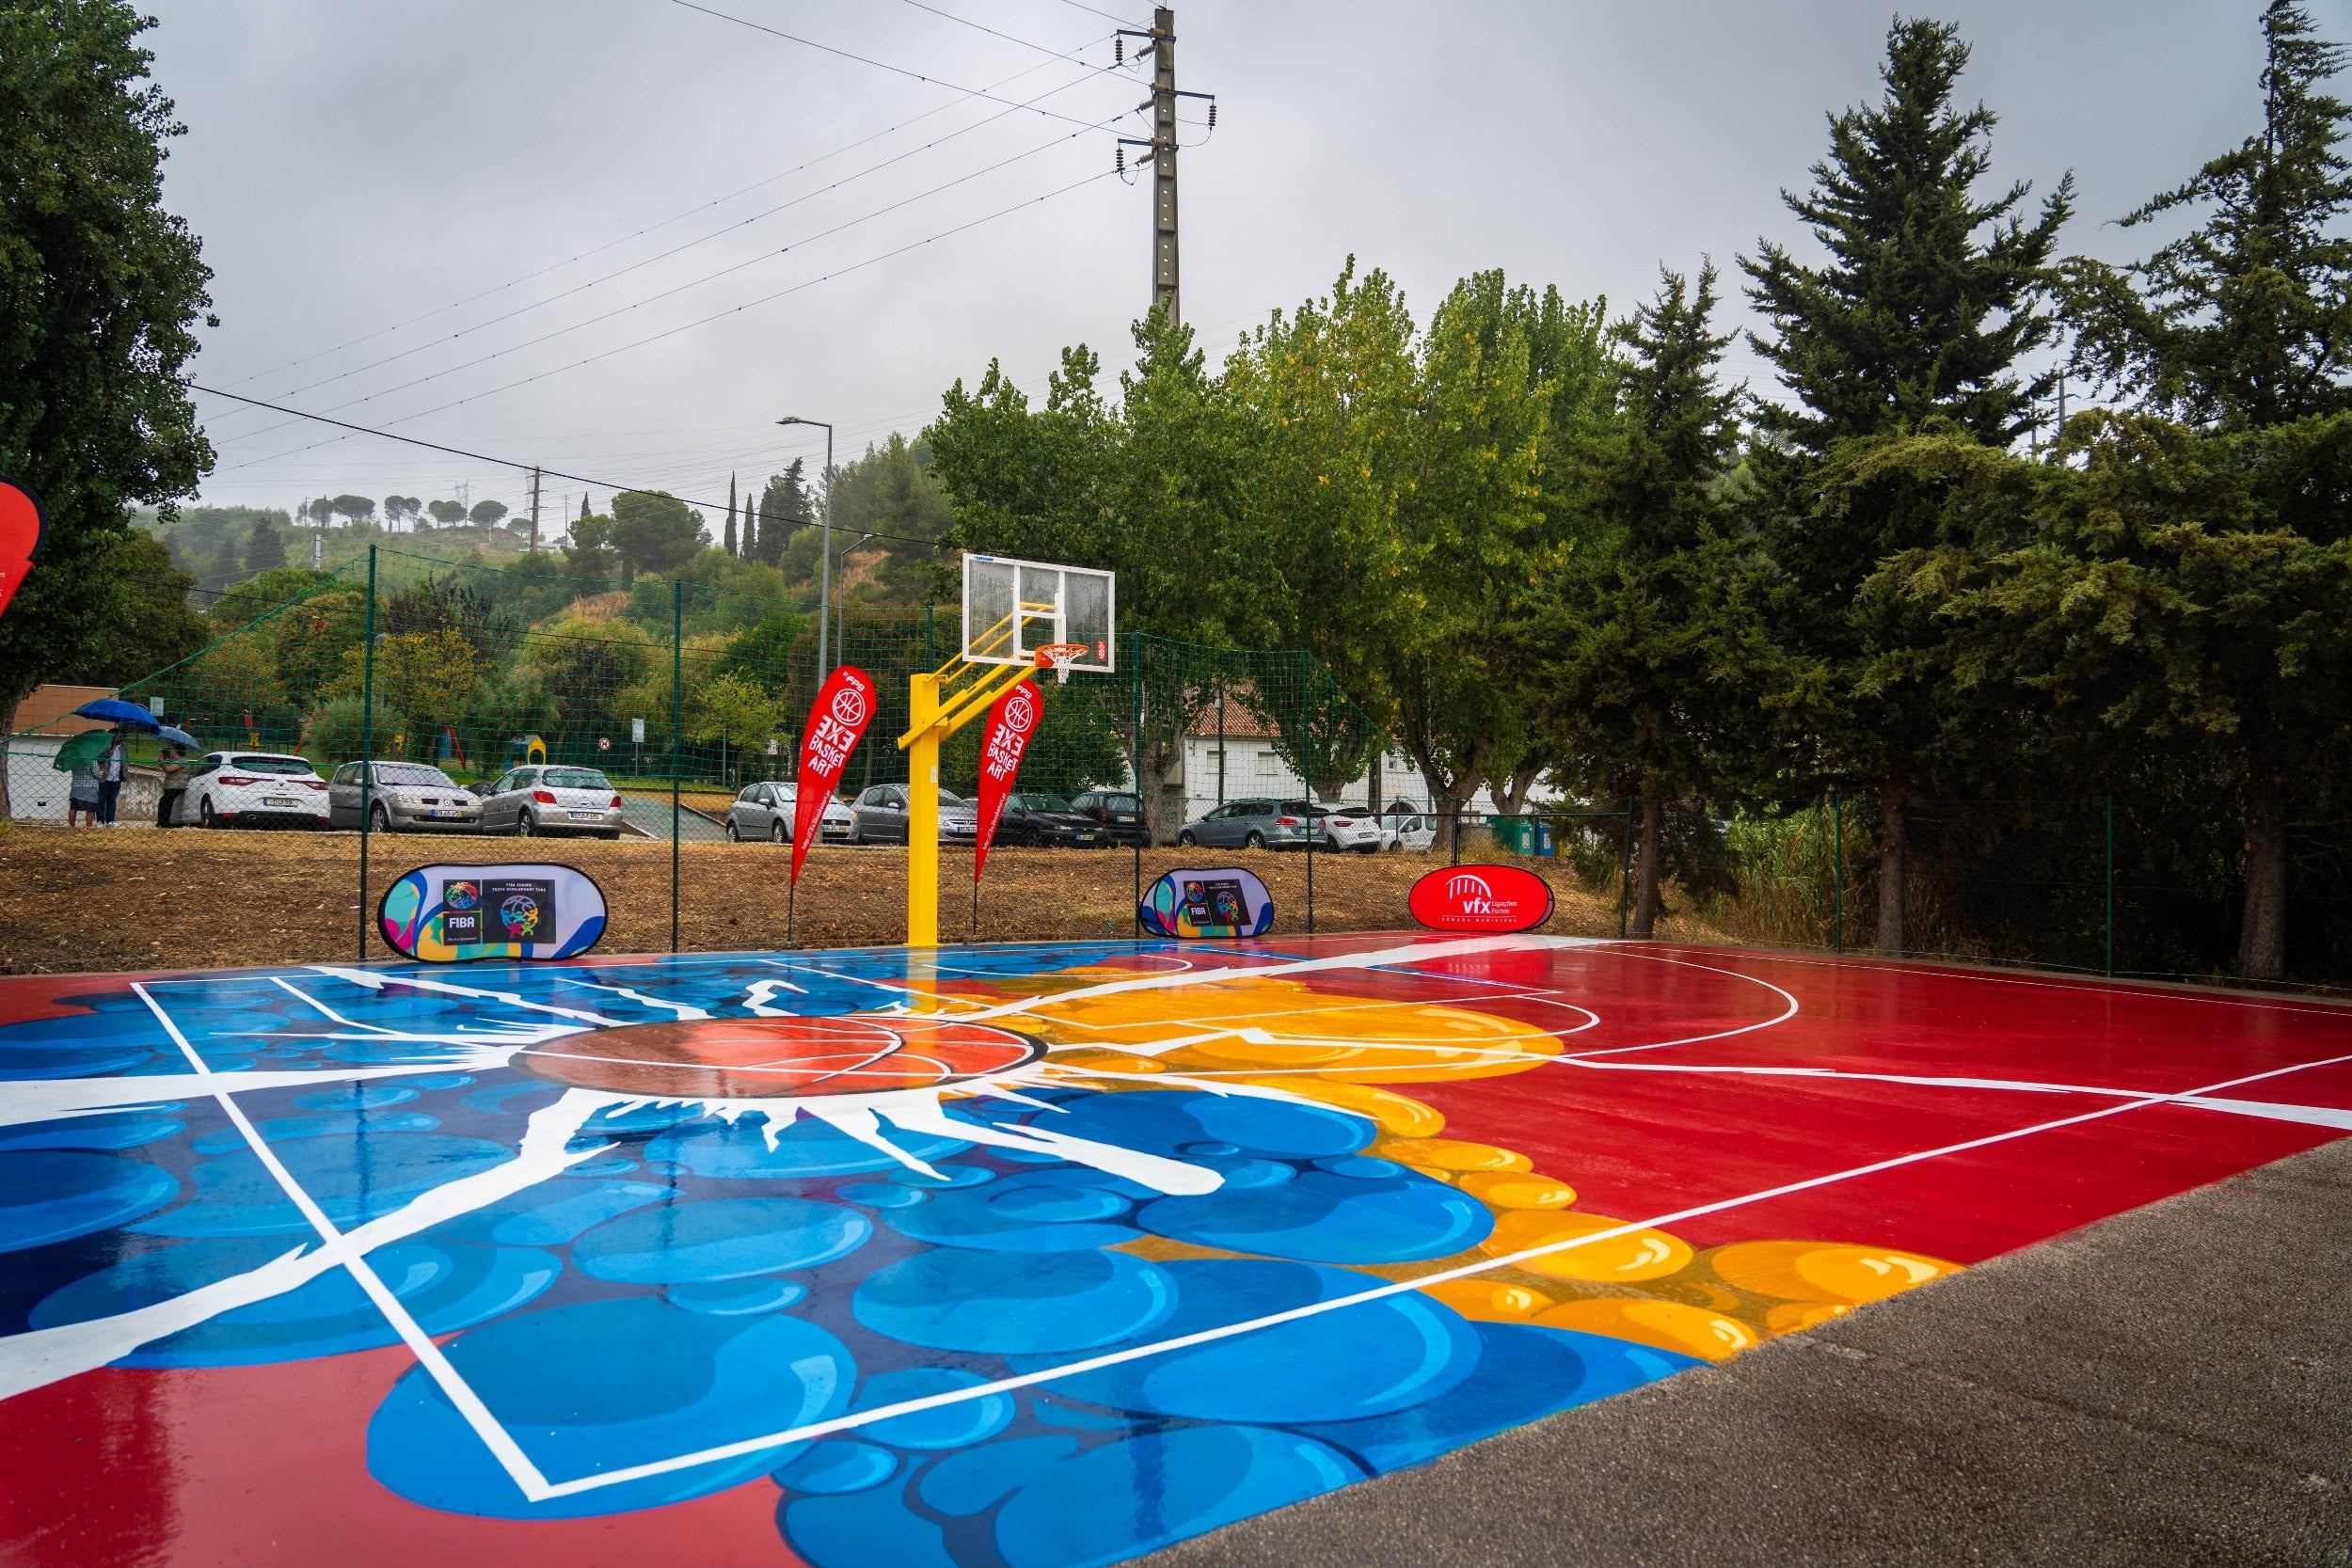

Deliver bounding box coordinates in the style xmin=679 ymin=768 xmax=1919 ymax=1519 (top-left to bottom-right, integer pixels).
xmin=524 ymin=1055 xmax=2352 ymax=1497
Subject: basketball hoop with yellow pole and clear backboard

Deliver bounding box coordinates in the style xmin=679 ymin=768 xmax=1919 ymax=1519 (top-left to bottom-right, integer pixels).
xmin=898 ymin=555 xmax=1118 ymax=947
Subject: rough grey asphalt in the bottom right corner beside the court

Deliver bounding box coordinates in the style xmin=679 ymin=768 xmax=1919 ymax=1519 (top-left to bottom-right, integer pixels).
xmin=1141 ymin=1140 xmax=2352 ymax=1568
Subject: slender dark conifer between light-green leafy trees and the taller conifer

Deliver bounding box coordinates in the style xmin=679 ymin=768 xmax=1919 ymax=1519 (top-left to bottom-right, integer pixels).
xmin=1515 ymin=265 xmax=1773 ymax=938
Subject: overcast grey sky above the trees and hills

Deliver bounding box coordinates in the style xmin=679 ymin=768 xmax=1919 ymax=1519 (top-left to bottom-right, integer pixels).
xmin=149 ymin=0 xmax=2277 ymax=529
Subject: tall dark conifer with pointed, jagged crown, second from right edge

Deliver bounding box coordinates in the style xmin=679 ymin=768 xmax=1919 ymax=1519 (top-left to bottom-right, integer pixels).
xmin=1740 ymin=19 xmax=2074 ymax=952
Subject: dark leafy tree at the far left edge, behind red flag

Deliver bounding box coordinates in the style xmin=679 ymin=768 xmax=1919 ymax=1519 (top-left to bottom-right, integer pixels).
xmin=0 ymin=0 xmax=212 ymax=761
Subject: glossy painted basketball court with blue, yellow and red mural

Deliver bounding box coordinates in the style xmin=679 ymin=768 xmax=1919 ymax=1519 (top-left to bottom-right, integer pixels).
xmin=0 ymin=936 xmax=2352 ymax=1568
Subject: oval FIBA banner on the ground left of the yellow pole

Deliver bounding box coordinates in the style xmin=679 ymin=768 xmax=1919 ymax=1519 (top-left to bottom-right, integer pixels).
xmin=376 ymin=865 xmax=605 ymax=964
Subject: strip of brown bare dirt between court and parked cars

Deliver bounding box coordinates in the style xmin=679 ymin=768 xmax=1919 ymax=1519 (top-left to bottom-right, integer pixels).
xmin=0 ymin=825 xmax=1722 ymax=974
